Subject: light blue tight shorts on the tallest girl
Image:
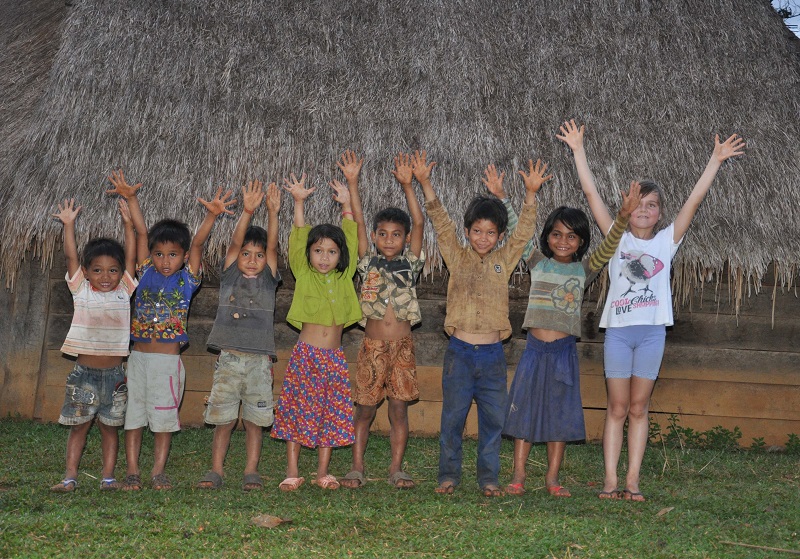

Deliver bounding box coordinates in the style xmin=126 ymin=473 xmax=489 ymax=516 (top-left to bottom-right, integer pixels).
xmin=603 ymin=324 xmax=667 ymax=380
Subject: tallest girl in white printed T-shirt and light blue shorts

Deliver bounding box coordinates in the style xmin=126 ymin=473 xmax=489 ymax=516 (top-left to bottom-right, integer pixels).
xmin=556 ymin=120 xmax=745 ymax=501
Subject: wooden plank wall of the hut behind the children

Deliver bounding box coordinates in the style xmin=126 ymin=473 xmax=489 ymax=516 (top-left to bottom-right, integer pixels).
xmin=23 ymin=258 xmax=800 ymax=445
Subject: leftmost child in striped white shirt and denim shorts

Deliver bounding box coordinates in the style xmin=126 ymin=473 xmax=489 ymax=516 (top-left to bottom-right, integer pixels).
xmin=50 ymin=199 xmax=137 ymax=493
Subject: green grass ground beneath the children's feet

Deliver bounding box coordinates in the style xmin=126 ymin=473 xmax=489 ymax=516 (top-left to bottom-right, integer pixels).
xmin=0 ymin=420 xmax=800 ymax=559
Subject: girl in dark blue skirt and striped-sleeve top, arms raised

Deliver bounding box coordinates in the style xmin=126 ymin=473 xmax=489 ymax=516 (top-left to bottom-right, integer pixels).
xmin=487 ymin=176 xmax=639 ymax=497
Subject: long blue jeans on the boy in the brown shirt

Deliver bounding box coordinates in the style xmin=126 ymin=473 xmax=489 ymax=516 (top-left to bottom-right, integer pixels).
xmin=439 ymin=337 xmax=507 ymax=487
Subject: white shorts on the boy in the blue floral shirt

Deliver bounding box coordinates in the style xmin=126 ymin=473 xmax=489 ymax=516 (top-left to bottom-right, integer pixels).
xmin=125 ymin=351 xmax=186 ymax=433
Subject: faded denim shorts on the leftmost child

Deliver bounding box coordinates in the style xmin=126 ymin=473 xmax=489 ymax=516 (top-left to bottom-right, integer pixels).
xmin=58 ymin=363 xmax=128 ymax=427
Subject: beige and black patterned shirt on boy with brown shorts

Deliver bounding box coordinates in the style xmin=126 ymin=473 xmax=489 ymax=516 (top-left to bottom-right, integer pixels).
xmin=358 ymin=251 xmax=425 ymax=326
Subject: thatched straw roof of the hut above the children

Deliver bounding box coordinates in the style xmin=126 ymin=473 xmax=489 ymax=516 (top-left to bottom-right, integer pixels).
xmin=0 ymin=0 xmax=800 ymax=316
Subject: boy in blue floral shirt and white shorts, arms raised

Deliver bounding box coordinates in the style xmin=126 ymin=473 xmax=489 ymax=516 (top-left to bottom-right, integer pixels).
xmin=107 ymin=171 xmax=236 ymax=491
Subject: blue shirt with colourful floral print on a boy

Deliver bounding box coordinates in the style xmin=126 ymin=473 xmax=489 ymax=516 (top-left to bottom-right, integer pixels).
xmin=131 ymin=258 xmax=202 ymax=344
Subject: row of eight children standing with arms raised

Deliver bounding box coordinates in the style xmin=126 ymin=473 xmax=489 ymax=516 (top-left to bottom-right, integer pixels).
xmin=52 ymin=121 xmax=744 ymax=501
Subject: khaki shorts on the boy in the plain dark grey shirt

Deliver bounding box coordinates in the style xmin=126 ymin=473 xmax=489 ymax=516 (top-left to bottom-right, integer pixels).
xmin=203 ymin=350 xmax=274 ymax=427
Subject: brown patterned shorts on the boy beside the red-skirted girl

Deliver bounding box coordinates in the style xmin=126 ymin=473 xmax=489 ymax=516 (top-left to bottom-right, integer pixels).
xmin=353 ymin=335 xmax=419 ymax=406
